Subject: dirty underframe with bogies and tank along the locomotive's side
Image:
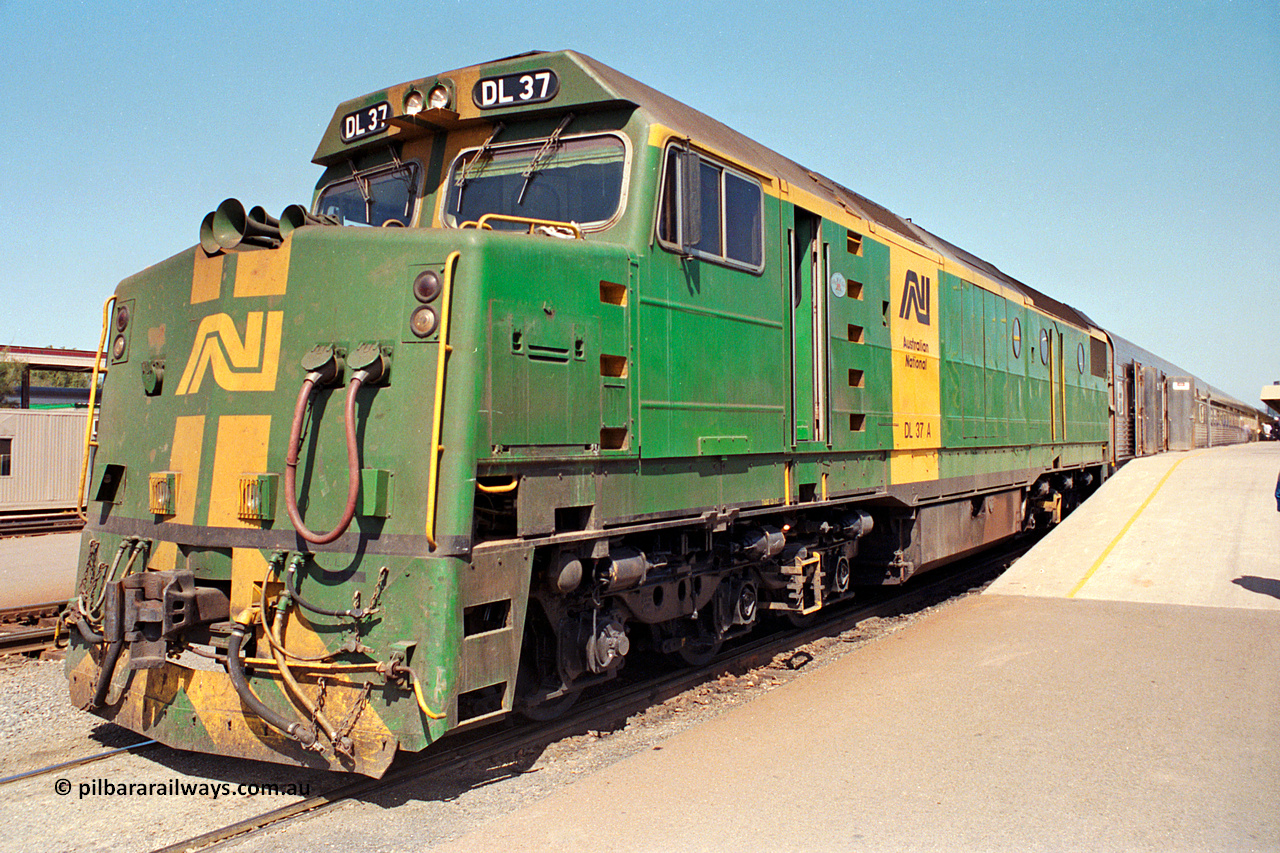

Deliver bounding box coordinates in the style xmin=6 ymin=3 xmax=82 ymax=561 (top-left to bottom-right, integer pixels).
xmin=474 ymin=450 xmax=1106 ymax=716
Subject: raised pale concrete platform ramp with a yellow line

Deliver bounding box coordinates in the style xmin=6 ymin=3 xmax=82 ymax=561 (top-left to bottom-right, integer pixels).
xmin=988 ymin=442 xmax=1280 ymax=610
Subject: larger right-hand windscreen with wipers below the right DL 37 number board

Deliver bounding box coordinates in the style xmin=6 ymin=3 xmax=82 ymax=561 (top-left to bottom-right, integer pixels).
xmin=445 ymin=136 xmax=626 ymax=229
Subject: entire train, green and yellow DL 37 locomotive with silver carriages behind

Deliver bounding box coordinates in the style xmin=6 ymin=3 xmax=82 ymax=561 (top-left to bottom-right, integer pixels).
xmin=67 ymin=51 xmax=1257 ymax=775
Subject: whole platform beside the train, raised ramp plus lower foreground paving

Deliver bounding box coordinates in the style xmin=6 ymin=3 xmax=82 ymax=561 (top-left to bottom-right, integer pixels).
xmin=433 ymin=446 xmax=1280 ymax=853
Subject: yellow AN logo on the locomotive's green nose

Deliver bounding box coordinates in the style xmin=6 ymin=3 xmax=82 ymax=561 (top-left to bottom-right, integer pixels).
xmin=175 ymin=311 xmax=284 ymax=396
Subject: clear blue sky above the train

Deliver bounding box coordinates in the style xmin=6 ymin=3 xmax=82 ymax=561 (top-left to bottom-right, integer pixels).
xmin=0 ymin=0 xmax=1280 ymax=405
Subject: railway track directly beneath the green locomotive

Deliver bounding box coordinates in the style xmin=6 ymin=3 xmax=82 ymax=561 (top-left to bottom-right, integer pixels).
xmin=152 ymin=539 xmax=1034 ymax=853
